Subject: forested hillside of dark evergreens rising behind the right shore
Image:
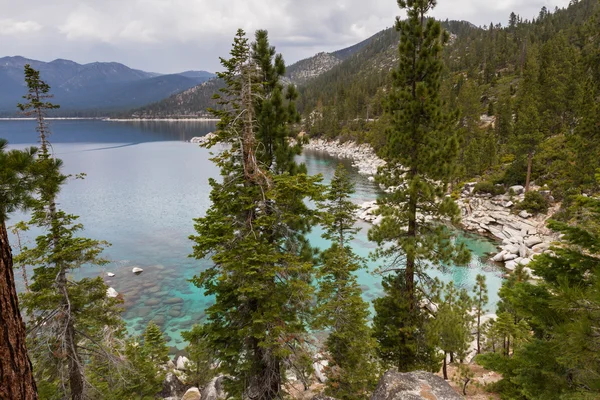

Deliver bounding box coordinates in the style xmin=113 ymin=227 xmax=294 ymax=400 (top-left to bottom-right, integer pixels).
xmin=298 ymin=0 xmax=599 ymax=197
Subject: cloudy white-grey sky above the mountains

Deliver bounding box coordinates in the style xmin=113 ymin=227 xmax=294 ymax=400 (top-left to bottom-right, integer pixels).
xmin=0 ymin=0 xmax=569 ymax=73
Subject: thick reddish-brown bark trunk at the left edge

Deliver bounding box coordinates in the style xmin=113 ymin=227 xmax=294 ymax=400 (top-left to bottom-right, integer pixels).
xmin=0 ymin=223 xmax=38 ymax=400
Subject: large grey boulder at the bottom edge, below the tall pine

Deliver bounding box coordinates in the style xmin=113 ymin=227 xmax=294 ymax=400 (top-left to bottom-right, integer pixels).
xmin=371 ymin=370 xmax=462 ymax=400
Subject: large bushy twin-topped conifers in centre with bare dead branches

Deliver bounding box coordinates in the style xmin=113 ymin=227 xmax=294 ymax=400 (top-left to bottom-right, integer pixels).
xmin=192 ymin=30 xmax=321 ymax=400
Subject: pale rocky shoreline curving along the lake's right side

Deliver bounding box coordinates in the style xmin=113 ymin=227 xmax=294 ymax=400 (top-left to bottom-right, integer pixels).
xmin=304 ymin=139 xmax=559 ymax=278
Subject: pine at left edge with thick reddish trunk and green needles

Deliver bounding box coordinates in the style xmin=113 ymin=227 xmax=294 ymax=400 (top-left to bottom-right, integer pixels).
xmin=0 ymin=139 xmax=38 ymax=400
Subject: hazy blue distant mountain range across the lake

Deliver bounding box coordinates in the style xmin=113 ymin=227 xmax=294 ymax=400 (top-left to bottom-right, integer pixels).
xmin=0 ymin=56 xmax=215 ymax=116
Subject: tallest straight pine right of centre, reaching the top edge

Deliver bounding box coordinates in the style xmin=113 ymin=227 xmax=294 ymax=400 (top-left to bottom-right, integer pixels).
xmin=369 ymin=0 xmax=469 ymax=371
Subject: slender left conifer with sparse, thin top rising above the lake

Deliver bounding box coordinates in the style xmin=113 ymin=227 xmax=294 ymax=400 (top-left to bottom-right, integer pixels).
xmin=17 ymin=65 xmax=123 ymax=400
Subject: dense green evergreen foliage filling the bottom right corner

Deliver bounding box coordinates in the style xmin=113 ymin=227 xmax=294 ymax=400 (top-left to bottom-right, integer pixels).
xmin=479 ymin=197 xmax=600 ymax=399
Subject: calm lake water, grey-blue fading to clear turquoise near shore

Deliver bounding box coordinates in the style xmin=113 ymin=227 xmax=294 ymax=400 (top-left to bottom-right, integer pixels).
xmin=0 ymin=120 xmax=502 ymax=348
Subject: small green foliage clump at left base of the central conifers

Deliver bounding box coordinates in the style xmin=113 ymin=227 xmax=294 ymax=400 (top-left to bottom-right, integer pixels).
xmin=181 ymin=324 xmax=217 ymax=387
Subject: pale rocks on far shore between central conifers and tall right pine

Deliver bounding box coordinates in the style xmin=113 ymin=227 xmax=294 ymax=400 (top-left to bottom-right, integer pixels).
xmin=304 ymin=139 xmax=385 ymax=176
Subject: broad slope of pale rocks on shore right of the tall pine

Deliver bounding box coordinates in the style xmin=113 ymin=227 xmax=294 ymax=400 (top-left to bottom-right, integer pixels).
xmin=458 ymin=182 xmax=558 ymax=276
